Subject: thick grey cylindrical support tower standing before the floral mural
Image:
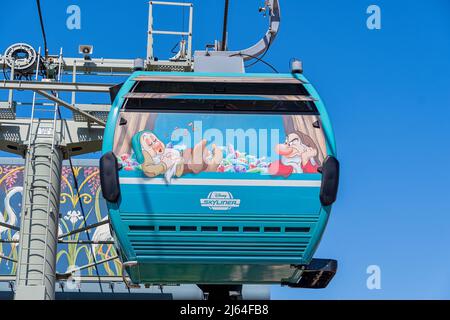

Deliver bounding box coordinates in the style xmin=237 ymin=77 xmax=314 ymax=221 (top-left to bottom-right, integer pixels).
xmin=15 ymin=120 xmax=63 ymax=300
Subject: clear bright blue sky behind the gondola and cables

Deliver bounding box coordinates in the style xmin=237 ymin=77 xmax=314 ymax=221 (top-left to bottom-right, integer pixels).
xmin=0 ymin=0 xmax=450 ymax=299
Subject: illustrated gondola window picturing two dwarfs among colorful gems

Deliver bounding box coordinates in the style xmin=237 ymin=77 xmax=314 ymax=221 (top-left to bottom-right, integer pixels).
xmin=114 ymin=112 xmax=326 ymax=183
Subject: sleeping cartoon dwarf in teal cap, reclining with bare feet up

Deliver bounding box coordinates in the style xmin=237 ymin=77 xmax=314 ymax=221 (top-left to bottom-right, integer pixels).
xmin=132 ymin=130 xmax=223 ymax=183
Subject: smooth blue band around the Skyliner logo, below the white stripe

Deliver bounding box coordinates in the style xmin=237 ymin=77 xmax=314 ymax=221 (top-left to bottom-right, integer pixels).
xmin=120 ymin=184 xmax=321 ymax=216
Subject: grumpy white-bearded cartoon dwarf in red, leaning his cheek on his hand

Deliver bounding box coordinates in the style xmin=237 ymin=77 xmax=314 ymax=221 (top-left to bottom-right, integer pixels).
xmin=269 ymin=131 xmax=321 ymax=177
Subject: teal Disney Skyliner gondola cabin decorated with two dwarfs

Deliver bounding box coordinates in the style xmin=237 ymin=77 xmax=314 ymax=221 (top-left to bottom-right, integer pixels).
xmin=100 ymin=72 xmax=339 ymax=287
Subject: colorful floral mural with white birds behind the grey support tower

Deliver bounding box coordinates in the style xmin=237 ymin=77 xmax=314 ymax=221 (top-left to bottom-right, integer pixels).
xmin=0 ymin=160 xmax=121 ymax=276
